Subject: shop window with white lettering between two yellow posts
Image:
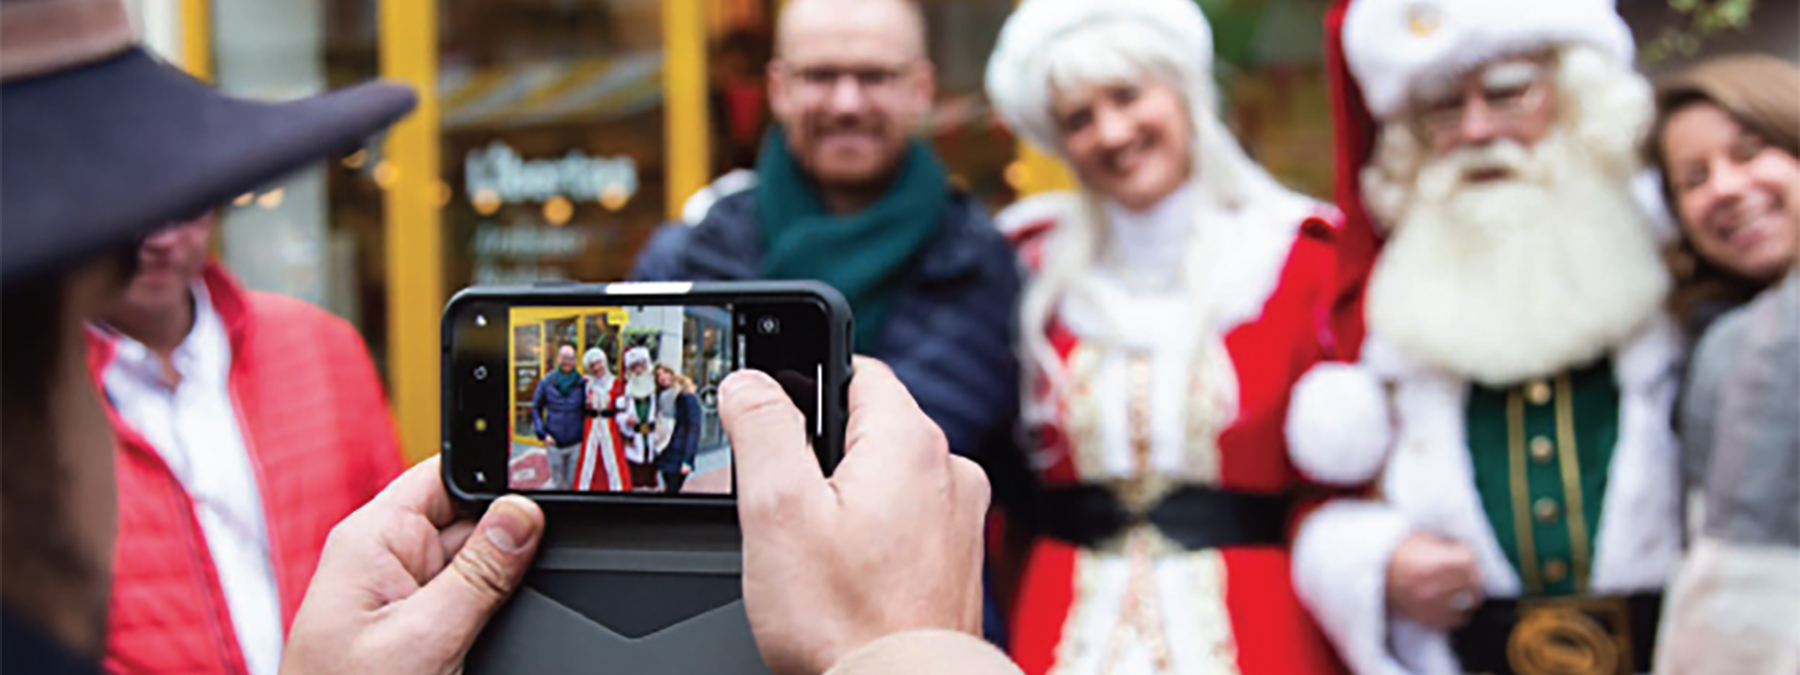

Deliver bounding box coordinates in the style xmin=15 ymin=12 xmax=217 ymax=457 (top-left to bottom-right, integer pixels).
xmin=439 ymin=0 xmax=666 ymax=288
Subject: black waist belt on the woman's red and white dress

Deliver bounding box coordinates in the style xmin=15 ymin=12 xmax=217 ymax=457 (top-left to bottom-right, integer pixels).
xmin=1040 ymin=484 xmax=1291 ymax=551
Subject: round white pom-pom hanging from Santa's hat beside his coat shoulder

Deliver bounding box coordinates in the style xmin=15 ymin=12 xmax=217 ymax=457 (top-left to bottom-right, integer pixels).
xmin=1287 ymin=364 xmax=1393 ymax=486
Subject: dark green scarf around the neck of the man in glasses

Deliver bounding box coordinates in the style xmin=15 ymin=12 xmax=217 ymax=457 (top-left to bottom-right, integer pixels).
xmin=756 ymin=128 xmax=950 ymax=353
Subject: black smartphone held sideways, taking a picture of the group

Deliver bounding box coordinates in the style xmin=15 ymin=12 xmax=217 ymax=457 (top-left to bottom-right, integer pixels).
xmin=443 ymin=281 xmax=851 ymax=506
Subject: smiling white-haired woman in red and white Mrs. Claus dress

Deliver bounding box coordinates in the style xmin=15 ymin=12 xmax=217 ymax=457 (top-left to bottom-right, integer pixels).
xmin=986 ymin=0 xmax=1361 ymax=675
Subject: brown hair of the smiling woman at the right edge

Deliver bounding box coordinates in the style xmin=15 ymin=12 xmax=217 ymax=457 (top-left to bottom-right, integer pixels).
xmin=1645 ymin=54 xmax=1800 ymax=335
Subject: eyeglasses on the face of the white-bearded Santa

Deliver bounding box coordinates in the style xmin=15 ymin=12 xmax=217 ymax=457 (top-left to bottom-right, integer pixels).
xmin=1413 ymin=56 xmax=1555 ymax=142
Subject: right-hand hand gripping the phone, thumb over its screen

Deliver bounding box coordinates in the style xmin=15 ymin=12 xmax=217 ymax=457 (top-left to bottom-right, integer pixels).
xmin=720 ymin=358 xmax=988 ymax=675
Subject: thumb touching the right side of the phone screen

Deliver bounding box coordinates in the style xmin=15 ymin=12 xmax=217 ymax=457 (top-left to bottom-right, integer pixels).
xmin=718 ymin=371 xmax=824 ymax=513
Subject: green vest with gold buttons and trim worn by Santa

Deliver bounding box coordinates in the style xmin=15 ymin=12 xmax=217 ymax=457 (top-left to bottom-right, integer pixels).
xmin=1463 ymin=360 xmax=1620 ymax=598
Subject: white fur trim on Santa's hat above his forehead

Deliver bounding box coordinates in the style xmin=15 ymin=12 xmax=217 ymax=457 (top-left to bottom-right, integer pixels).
xmin=1343 ymin=0 xmax=1634 ymax=119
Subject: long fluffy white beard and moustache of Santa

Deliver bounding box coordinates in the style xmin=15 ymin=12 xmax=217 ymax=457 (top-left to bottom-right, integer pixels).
xmin=1368 ymin=133 xmax=1669 ymax=385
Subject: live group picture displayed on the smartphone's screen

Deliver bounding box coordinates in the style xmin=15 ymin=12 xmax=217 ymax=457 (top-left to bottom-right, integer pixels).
xmin=506 ymin=304 xmax=738 ymax=495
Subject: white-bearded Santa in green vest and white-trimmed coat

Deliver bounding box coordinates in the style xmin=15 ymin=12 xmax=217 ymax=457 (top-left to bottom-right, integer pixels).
xmin=1289 ymin=0 xmax=1679 ymax=675
